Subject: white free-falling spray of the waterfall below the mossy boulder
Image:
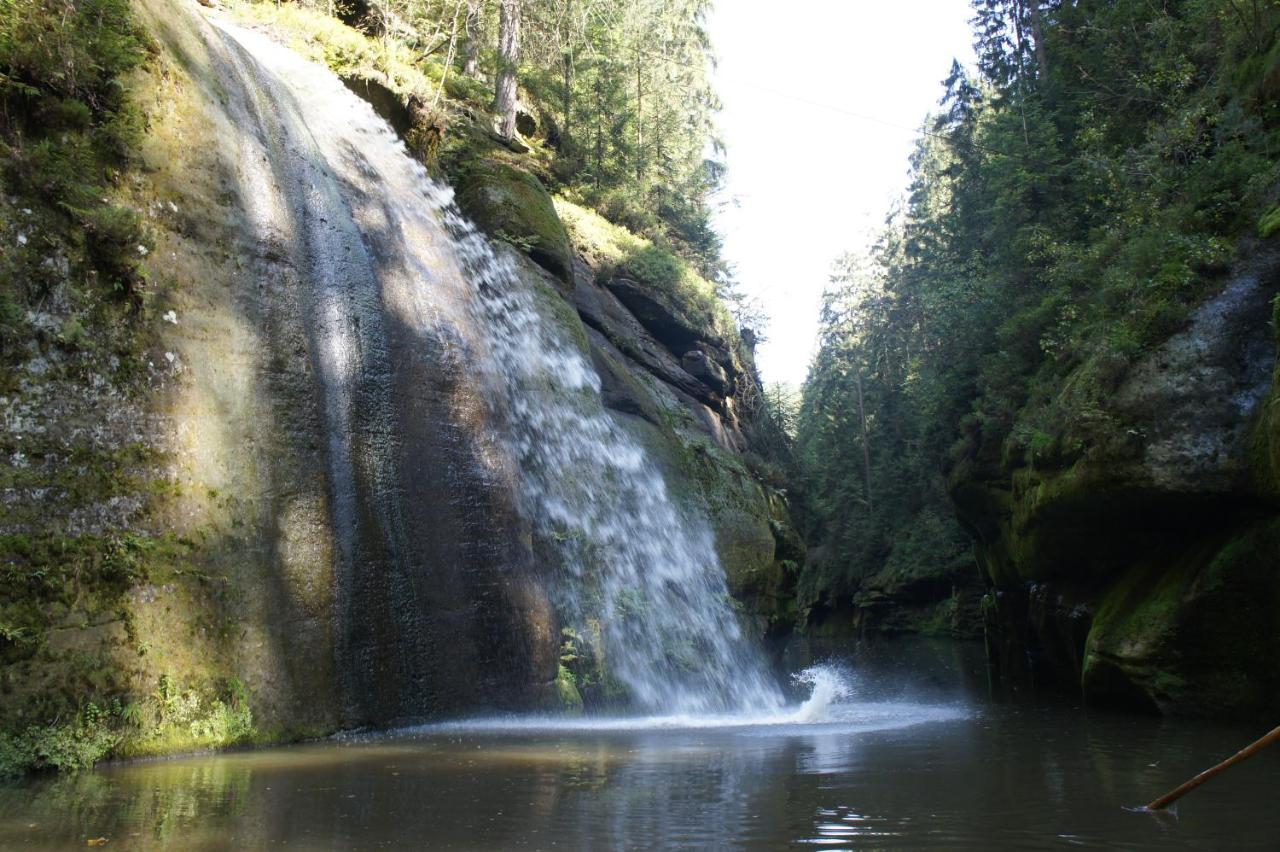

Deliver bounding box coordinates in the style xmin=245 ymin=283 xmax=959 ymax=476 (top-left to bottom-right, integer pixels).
xmin=437 ymin=197 xmax=782 ymax=713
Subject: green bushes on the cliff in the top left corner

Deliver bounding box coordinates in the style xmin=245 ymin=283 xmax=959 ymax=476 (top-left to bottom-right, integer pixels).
xmin=0 ymin=0 xmax=150 ymax=358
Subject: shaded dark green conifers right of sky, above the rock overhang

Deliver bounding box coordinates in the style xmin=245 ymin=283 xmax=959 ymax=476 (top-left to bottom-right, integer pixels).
xmin=797 ymin=0 xmax=1280 ymax=611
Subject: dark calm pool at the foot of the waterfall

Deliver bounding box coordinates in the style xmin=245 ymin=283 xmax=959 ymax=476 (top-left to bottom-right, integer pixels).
xmin=0 ymin=647 xmax=1280 ymax=849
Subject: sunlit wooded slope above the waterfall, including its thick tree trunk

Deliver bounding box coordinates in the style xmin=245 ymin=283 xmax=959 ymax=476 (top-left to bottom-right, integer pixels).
xmin=325 ymin=0 xmax=737 ymax=278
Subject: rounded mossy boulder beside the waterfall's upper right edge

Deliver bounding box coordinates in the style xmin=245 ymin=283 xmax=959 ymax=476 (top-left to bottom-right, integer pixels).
xmin=457 ymin=159 xmax=573 ymax=285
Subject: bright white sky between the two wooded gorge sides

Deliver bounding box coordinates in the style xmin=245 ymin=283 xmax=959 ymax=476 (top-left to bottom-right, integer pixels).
xmin=710 ymin=0 xmax=973 ymax=385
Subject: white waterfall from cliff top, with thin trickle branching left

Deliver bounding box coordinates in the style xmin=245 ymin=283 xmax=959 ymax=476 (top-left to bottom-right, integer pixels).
xmin=208 ymin=16 xmax=782 ymax=714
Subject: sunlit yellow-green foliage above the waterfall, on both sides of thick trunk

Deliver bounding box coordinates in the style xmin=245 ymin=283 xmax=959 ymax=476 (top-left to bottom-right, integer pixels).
xmin=252 ymin=0 xmax=727 ymax=289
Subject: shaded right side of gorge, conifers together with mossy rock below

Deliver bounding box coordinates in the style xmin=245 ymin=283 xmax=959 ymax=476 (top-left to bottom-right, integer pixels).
xmin=797 ymin=0 xmax=1280 ymax=706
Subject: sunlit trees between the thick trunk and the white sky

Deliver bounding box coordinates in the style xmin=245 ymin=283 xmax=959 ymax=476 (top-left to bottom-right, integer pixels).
xmin=522 ymin=0 xmax=723 ymax=272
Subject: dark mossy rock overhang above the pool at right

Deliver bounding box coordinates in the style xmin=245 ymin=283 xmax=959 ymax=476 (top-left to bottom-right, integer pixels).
xmin=951 ymin=248 xmax=1280 ymax=714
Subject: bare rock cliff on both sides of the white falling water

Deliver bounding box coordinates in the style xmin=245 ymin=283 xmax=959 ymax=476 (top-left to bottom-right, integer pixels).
xmin=0 ymin=3 xmax=803 ymax=753
